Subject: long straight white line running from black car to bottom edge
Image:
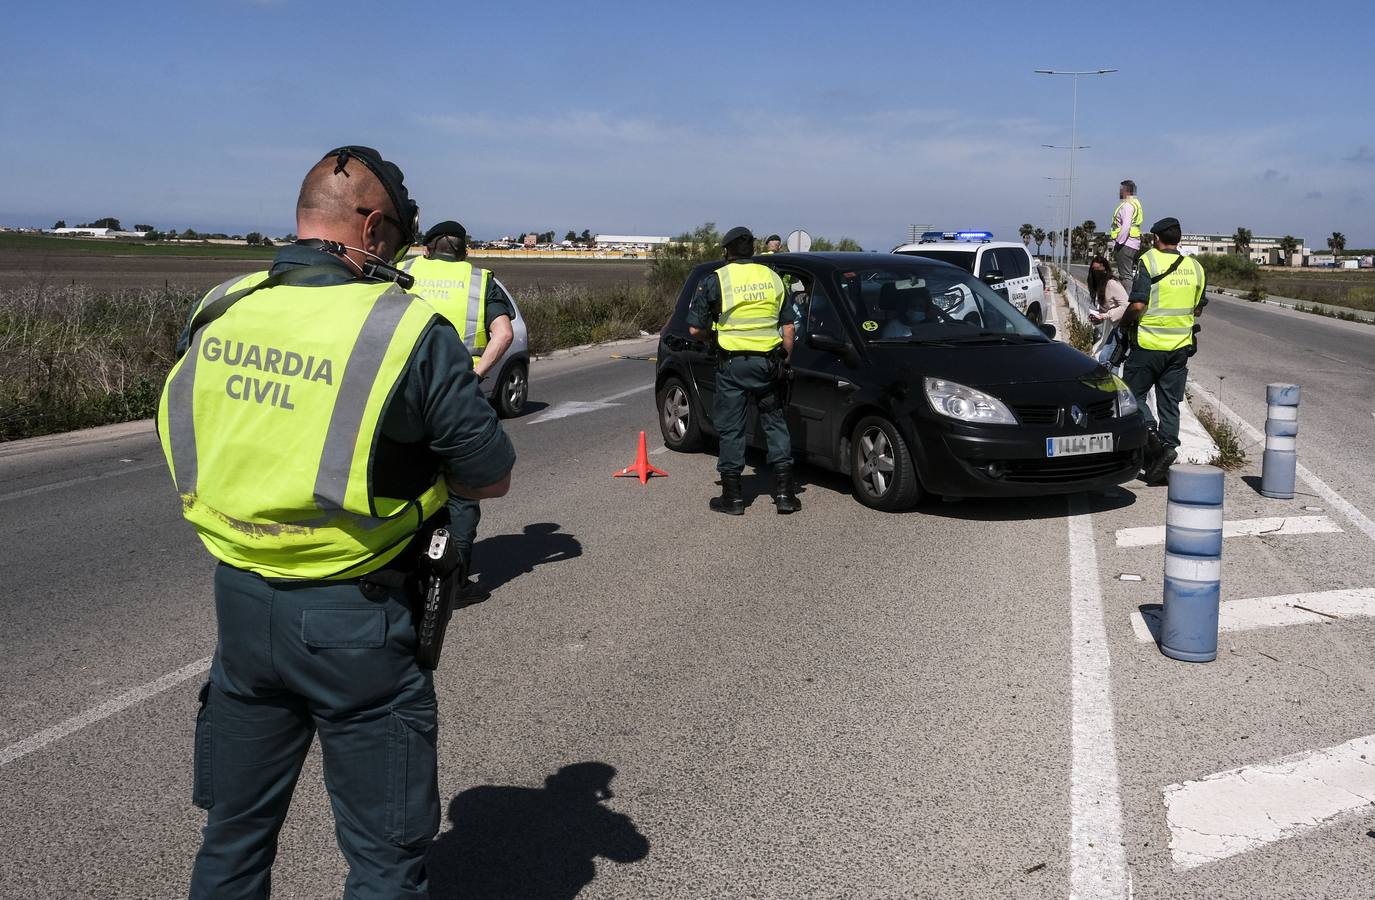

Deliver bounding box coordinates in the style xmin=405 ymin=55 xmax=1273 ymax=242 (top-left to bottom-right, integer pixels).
xmin=1068 ymin=495 xmax=1132 ymax=900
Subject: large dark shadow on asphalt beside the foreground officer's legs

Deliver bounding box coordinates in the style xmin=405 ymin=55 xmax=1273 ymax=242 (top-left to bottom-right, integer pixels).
xmin=426 ymin=763 xmax=649 ymax=900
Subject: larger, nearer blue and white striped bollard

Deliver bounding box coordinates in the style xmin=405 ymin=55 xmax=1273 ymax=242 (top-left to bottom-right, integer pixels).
xmin=1161 ymin=463 xmax=1222 ymax=662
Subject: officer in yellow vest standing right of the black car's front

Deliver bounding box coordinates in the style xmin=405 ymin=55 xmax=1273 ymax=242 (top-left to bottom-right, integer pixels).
xmin=1122 ymin=217 xmax=1207 ymax=485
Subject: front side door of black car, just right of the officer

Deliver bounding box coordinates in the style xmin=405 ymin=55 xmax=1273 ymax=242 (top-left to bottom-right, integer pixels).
xmin=788 ymin=272 xmax=855 ymax=464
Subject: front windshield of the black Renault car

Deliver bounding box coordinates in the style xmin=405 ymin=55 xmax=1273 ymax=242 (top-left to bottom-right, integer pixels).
xmin=839 ymin=265 xmax=1049 ymax=344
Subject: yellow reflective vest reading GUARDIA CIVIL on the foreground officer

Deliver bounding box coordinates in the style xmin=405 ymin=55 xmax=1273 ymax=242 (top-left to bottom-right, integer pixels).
xmin=158 ymin=282 xmax=448 ymax=580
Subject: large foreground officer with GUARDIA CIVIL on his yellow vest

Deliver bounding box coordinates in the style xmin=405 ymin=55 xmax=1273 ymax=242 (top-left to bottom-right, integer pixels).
xmin=158 ymin=147 xmax=516 ymax=900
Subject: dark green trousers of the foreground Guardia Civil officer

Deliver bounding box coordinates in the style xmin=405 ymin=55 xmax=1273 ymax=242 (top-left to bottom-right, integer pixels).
xmin=190 ymin=565 xmax=440 ymax=900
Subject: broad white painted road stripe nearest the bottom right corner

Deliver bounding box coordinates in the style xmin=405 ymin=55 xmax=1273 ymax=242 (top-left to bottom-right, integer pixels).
xmin=1165 ymin=735 xmax=1375 ymax=870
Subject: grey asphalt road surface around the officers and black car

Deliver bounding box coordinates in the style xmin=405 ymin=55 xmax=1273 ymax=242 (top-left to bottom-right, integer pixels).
xmin=0 ymin=304 xmax=1375 ymax=899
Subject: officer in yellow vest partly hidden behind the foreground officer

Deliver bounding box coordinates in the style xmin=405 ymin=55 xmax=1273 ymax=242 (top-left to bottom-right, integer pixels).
xmin=400 ymin=220 xmax=514 ymax=602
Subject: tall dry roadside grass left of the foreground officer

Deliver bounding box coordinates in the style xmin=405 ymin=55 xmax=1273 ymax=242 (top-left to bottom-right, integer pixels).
xmin=0 ymin=284 xmax=197 ymax=441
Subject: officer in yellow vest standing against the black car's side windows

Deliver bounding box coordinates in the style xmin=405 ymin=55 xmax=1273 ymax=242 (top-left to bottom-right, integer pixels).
xmin=688 ymin=228 xmax=802 ymax=515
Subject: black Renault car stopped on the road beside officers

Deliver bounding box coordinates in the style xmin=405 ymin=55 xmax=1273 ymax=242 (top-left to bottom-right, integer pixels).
xmin=655 ymin=253 xmax=1147 ymax=510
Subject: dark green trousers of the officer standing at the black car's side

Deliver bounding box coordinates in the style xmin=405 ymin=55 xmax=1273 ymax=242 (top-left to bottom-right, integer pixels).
xmin=711 ymin=356 xmax=792 ymax=475
